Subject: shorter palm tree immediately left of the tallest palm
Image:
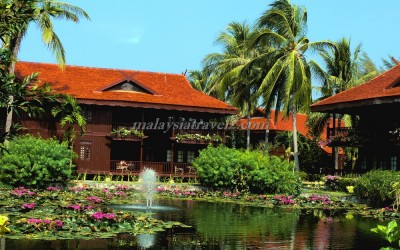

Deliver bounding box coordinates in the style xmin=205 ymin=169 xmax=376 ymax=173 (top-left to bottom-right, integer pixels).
xmin=204 ymin=22 xmax=261 ymax=149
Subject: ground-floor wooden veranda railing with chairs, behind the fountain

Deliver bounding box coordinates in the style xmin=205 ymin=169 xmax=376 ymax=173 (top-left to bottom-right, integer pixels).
xmin=110 ymin=160 xmax=195 ymax=176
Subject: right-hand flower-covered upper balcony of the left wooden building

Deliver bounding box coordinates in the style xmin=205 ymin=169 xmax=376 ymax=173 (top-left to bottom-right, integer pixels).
xmin=171 ymin=129 xmax=225 ymax=145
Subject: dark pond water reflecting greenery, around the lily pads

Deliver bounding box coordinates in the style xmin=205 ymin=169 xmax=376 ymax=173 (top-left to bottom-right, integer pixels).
xmin=0 ymin=200 xmax=386 ymax=250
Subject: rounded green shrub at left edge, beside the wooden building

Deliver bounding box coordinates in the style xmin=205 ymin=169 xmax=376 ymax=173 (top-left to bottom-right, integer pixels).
xmin=0 ymin=135 xmax=76 ymax=188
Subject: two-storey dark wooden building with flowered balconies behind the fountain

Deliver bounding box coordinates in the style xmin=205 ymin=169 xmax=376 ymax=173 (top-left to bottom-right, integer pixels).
xmin=16 ymin=62 xmax=237 ymax=176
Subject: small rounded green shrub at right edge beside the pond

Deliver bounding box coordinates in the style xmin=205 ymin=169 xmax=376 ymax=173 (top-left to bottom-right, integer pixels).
xmin=354 ymin=170 xmax=400 ymax=207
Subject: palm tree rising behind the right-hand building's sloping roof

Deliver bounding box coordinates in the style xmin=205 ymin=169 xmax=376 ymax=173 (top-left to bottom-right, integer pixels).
xmin=309 ymin=37 xmax=378 ymax=169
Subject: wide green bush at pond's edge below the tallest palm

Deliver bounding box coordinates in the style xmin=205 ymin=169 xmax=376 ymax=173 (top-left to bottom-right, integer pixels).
xmin=193 ymin=146 xmax=301 ymax=194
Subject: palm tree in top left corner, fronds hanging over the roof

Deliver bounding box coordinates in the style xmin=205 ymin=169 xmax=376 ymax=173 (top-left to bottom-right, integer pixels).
xmin=3 ymin=0 xmax=90 ymax=136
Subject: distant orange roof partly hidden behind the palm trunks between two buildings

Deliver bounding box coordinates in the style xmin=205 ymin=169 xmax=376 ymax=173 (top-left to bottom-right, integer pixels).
xmin=239 ymin=108 xmax=344 ymax=154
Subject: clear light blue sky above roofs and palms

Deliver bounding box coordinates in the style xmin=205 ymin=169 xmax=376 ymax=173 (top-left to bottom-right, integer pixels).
xmin=19 ymin=0 xmax=400 ymax=73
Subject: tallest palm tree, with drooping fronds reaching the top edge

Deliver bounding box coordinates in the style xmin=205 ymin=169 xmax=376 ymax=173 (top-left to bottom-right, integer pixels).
xmin=252 ymin=0 xmax=333 ymax=171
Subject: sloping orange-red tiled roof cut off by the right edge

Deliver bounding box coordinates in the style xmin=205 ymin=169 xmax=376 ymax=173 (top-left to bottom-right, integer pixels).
xmin=311 ymin=65 xmax=400 ymax=111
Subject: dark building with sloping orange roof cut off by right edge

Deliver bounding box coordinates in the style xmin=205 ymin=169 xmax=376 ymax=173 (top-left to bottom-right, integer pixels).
xmin=311 ymin=65 xmax=400 ymax=172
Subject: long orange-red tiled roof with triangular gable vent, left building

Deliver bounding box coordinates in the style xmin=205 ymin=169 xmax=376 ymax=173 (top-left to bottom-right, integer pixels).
xmin=15 ymin=62 xmax=237 ymax=114
